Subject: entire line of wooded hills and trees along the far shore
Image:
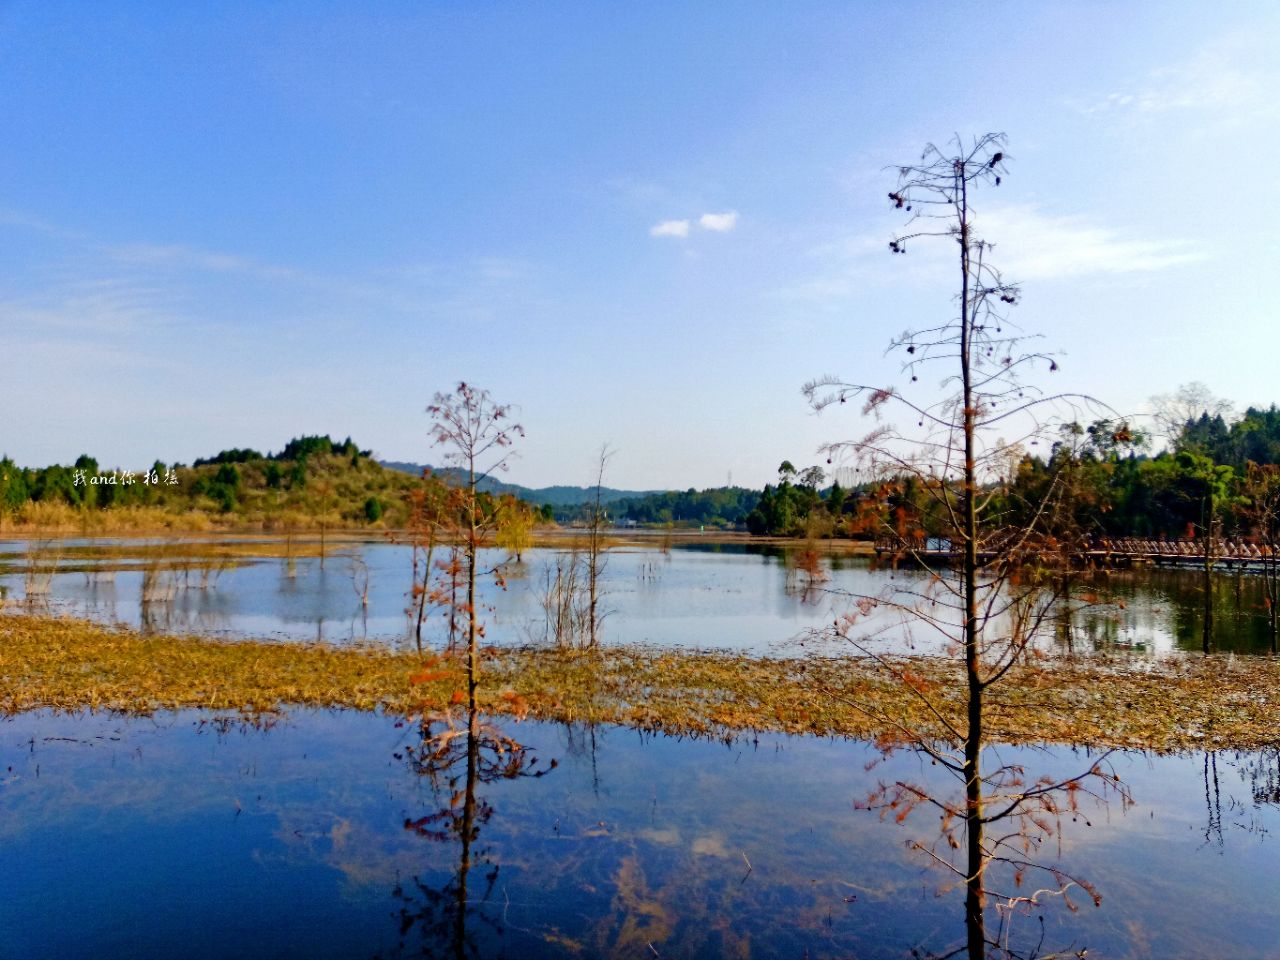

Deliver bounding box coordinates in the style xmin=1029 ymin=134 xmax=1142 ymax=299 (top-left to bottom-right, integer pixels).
xmin=10 ymin=396 xmax=1280 ymax=539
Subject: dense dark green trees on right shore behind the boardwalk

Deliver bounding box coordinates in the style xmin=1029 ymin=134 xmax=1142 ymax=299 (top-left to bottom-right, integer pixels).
xmin=745 ymin=406 xmax=1280 ymax=539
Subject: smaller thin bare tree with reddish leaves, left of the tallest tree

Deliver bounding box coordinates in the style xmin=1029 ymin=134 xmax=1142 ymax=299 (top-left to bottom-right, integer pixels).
xmin=426 ymin=383 xmax=525 ymax=722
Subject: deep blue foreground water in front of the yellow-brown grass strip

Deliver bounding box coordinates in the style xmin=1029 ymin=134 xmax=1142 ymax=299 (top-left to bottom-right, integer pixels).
xmin=0 ymin=710 xmax=1280 ymax=959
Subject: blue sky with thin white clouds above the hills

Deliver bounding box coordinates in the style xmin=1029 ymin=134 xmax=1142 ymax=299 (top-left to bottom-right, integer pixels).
xmin=0 ymin=3 xmax=1280 ymax=488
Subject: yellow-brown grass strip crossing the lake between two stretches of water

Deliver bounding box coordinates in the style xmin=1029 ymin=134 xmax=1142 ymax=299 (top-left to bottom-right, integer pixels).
xmin=0 ymin=614 xmax=1280 ymax=751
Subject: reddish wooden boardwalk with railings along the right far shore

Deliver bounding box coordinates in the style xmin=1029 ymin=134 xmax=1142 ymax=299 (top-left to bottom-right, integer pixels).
xmin=876 ymin=536 xmax=1280 ymax=570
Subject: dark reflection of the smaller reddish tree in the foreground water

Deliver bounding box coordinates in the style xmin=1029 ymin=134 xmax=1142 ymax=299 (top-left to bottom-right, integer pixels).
xmin=381 ymin=710 xmax=557 ymax=960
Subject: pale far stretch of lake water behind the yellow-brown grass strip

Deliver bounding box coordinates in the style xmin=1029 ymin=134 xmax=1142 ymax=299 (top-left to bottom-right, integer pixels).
xmin=0 ymin=540 xmax=1270 ymax=655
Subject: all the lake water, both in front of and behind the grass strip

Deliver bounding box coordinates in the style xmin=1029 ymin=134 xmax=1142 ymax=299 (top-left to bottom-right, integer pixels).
xmin=0 ymin=541 xmax=1280 ymax=960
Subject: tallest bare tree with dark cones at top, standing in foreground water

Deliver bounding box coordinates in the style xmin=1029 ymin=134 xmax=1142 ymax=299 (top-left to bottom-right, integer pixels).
xmin=805 ymin=133 xmax=1115 ymax=960
